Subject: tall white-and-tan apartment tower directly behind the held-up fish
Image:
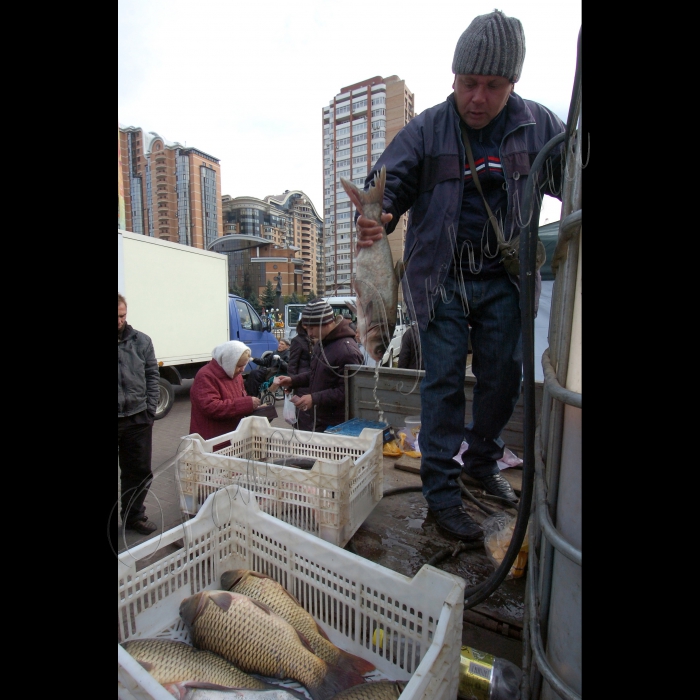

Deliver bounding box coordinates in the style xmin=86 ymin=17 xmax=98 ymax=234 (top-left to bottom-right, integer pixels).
xmin=323 ymin=75 xmax=415 ymax=296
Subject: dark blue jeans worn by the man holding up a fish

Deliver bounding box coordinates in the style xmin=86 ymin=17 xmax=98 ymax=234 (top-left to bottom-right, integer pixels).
xmin=419 ymin=275 xmax=523 ymax=511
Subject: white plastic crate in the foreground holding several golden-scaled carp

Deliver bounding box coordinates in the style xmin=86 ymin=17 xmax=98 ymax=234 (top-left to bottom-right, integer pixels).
xmin=118 ymin=485 xmax=464 ymax=700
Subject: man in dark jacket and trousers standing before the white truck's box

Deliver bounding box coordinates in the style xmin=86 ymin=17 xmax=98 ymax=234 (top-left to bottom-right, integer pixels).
xmin=118 ymin=294 xmax=160 ymax=546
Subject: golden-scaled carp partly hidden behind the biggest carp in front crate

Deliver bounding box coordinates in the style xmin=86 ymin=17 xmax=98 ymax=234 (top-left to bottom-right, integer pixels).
xmin=221 ymin=569 xmax=375 ymax=674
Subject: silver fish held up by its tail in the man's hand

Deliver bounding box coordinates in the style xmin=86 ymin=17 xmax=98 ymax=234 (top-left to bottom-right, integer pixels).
xmin=340 ymin=167 xmax=403 ymax=362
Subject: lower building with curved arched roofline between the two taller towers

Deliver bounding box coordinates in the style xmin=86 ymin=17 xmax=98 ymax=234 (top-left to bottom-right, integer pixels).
xmin=220 ymin=190 xmax=324 ymax=296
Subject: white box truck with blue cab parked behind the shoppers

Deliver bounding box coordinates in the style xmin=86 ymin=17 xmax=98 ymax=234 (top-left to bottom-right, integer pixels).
xmin=117 ymin=231 xmax=277 ymax=419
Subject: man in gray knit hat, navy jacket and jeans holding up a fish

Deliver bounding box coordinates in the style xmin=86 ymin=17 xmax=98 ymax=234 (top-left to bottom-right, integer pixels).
xmin=353 ymin=10 xmax=565 ymax=541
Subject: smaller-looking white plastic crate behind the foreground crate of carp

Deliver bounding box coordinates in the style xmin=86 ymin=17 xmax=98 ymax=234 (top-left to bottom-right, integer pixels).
xmin=176 ymin=416 xmax=384 ymax=547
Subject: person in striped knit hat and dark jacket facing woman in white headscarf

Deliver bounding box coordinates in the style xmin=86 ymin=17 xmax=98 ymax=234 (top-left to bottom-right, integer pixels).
xmin=277 ymin=299 xmax=362 ymax=432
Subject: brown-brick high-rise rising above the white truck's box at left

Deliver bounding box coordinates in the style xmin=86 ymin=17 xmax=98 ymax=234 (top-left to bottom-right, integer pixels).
xmin=119 ymin=126 xmax=223 ymax=249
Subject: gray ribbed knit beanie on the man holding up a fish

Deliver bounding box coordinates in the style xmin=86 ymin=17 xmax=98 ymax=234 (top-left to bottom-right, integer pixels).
xmin=452 ymin=10 xmax=525 ymax=83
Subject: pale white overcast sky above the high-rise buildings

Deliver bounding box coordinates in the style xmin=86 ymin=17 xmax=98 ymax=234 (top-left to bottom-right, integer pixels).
xmin=118 ymin=0 xmax=581 ymax=223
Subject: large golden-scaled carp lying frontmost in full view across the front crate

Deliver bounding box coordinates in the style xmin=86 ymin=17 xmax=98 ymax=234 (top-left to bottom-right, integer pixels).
xmin=180 ymin=591 xmax=364 ymax=700
